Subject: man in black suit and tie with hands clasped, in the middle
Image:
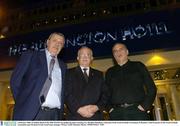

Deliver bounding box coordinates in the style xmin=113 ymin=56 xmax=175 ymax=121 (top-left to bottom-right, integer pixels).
xmin=66 ymin=47 xmax=107 ymax=120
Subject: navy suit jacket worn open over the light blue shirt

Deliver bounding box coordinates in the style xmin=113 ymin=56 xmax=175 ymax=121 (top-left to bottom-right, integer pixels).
xmin=10 ymin=51 xmax=66 ymax=120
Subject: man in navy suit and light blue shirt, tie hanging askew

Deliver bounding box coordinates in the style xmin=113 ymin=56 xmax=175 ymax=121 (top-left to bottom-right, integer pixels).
xmin=10 ymin=33 xmax=66 ymax=120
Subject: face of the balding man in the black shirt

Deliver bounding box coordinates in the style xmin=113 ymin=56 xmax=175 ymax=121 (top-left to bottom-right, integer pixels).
xmin=112 ymin=44 xmax=129 ymax=63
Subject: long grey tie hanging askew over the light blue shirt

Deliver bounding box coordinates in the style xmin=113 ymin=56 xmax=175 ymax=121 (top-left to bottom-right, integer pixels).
xmin=40 ymin=56 xmax=55 ymax=104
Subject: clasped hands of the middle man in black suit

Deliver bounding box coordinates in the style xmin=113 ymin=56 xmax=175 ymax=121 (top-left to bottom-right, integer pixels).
xmin=77 ymin=105 xmax=99 ymax=118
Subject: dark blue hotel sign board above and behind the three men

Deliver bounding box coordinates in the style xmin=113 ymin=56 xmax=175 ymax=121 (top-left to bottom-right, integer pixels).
xmin=0 ymin=9 xmax=180 ymax=61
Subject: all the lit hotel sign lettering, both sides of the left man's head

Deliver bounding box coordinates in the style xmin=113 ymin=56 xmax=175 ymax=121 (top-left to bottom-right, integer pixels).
xmin=8 ymin=22 xmax=172 ymax=56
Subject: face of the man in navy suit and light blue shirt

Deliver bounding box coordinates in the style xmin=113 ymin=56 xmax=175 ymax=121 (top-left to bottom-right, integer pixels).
xmin=47 ymin=34 xmax=65 ymax=56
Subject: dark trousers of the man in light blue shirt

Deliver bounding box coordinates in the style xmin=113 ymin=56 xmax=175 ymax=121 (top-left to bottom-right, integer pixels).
xmin=34 ymin=108 xmax=62 ymax=120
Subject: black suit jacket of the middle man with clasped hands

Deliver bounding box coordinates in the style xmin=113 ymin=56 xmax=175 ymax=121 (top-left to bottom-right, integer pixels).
xmin=65 ymin=66 xmax=107 ymax=120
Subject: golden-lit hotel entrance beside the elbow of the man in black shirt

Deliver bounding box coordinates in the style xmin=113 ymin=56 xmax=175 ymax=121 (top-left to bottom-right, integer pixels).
xmin=151 ymin=68 xmax=180 ymax=120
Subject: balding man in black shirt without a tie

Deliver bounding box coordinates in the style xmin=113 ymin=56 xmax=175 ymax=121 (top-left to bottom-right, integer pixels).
xmin=106 ymin=43 xmax=157 ymax=120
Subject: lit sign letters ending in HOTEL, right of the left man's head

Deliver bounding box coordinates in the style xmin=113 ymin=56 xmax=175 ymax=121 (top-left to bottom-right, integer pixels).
xmin=66 ymin=22 xmax=172 ymax=47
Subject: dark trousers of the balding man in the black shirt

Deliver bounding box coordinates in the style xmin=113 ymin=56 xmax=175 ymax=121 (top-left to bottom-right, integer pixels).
xmin=109 ymin=105 xmax=150 ymax=120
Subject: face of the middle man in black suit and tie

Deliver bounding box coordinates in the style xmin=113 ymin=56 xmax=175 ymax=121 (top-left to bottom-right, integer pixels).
xmin=77 ymin=48 xmax=93 ymax=67
